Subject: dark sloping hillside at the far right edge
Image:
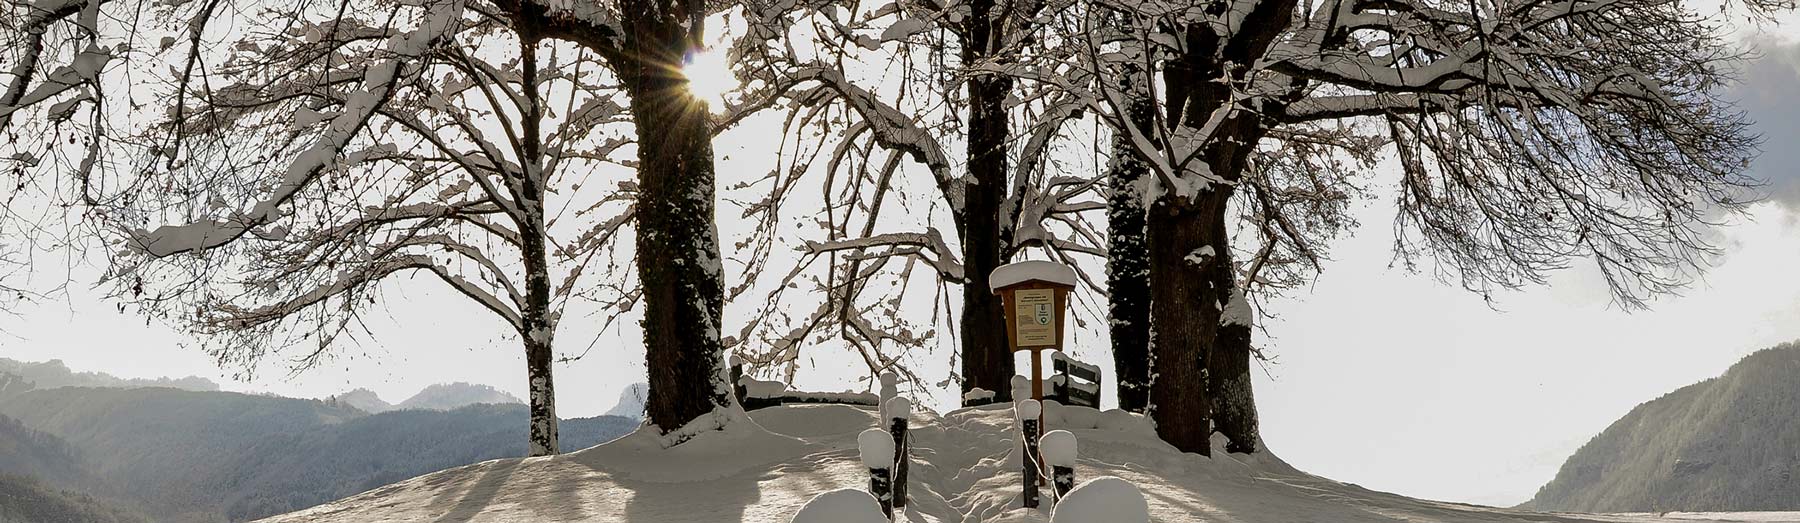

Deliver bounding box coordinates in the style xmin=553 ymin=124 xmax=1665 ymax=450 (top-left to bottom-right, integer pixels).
xmin=1521 ymin=343 xmax=1800 ymax=512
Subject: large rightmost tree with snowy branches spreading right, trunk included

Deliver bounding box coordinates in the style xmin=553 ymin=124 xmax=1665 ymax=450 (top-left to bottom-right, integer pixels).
xmin=1051 ymin=0 xmax=1791 ymax=453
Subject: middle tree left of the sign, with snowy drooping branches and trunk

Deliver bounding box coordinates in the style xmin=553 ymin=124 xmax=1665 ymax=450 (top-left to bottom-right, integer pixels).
xmin=738 ymin=0 xmax=1103 ymax=399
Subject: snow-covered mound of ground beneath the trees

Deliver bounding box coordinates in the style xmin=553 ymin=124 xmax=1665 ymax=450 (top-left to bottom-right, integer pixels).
xmin=263 ymin=404 xmax=1800 ymax=523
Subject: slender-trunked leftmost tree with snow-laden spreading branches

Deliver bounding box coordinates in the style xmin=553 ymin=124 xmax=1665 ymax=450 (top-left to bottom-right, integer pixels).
xmin=113 ymin=0 xmax=648 ymax=455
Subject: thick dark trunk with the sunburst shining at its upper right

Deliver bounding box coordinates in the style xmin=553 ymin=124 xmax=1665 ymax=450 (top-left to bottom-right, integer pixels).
xmin=614 ymin=0 xmax=731 ymax=433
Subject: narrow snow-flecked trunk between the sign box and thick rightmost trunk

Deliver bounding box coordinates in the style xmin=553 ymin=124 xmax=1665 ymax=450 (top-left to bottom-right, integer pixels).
xmin=1107 ymin=45 xmax=1156 ymax=413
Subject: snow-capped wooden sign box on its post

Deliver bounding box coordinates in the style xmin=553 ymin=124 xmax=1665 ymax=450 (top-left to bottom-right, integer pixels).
xmin=988 ymin=261 xmax=1075 ymax=431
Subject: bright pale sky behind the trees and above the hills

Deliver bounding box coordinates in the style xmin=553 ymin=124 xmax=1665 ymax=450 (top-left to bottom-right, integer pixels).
xmin=0 ymin=15 xmax=1800 ymax=505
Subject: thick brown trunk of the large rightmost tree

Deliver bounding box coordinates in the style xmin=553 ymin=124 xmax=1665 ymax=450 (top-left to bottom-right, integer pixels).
xmin=1148 ymin=2 xmax=1294 ymax=455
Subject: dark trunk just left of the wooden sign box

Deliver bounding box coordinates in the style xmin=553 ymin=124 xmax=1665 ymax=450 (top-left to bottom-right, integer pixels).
xmin=958 ymin=0 xmax=1013 ymax=407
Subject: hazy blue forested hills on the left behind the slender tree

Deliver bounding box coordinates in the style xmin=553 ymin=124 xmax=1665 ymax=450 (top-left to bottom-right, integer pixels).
xmin=0 ymin=388 xmax=637 ymax=523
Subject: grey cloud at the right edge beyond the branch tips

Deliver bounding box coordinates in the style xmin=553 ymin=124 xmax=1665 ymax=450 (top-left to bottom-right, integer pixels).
xmin=1726 ymin=38 xmax=1800 ymax=208
